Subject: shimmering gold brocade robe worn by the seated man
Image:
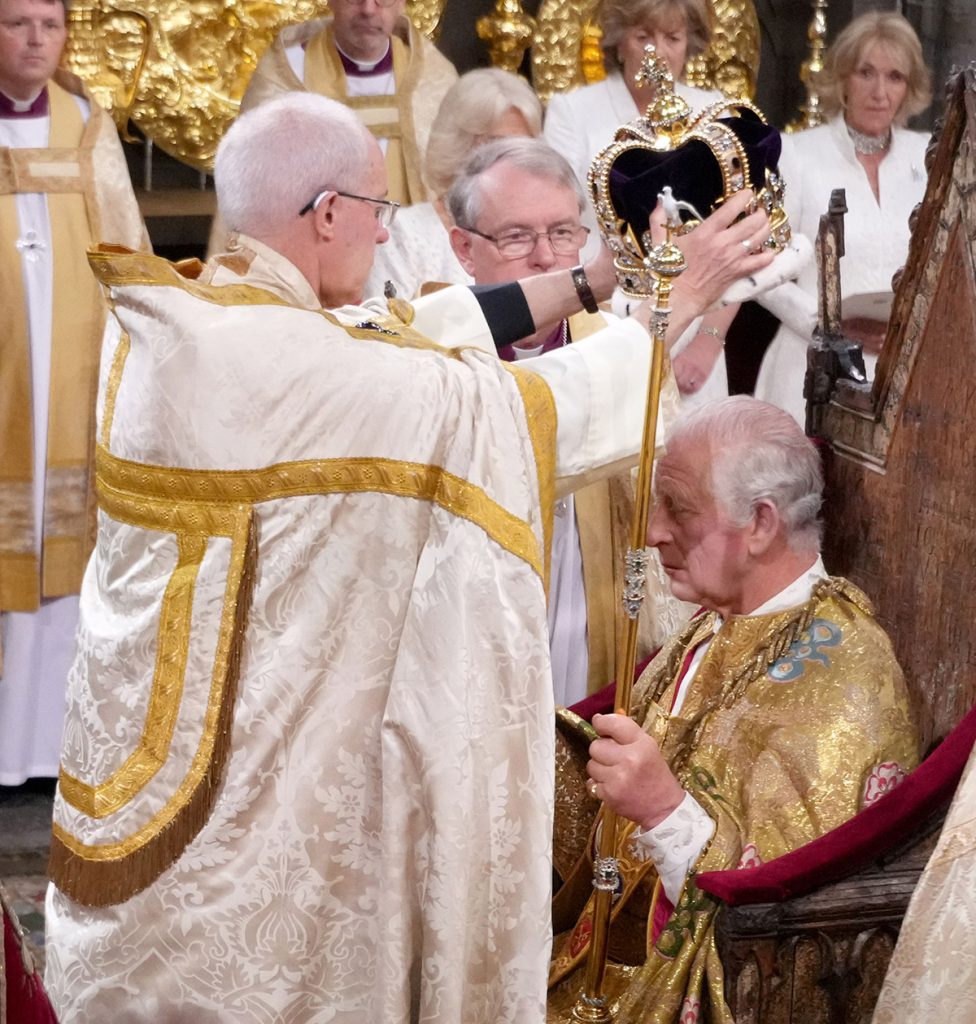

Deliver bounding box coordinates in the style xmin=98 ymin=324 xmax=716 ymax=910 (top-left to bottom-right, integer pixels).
xmin=549 ymin=579 xmax=918 ymax=1024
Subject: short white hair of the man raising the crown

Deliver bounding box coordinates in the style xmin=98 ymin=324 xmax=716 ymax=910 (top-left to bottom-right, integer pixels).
xmin=214 ymin=92 xmax=370 ymax=239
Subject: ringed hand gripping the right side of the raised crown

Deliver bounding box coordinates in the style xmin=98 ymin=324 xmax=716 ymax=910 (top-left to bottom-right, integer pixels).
xmin=675 ymin=188 xmax=775 ymax=309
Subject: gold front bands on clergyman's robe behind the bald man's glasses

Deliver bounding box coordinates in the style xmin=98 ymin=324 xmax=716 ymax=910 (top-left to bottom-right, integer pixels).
xmin=305 ymin=25 xmax=427 ymax=205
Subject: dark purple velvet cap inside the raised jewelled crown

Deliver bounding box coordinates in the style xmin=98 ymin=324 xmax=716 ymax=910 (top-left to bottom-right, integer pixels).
xmin=609 ymin=108 xmax=782 ymax=253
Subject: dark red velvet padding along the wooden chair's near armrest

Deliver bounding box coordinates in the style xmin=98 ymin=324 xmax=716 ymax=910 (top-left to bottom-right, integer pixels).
xmin=695 ymin=708 xmax=976 ymax=905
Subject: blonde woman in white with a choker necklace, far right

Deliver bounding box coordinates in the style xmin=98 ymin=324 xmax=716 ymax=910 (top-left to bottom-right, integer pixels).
xmin=756 ymin=11 xmax=931 ymax=425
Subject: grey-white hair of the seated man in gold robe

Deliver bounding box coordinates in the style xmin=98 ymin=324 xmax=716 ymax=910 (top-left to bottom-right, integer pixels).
xmin=668 ymin=395 xmax=823 ymax=554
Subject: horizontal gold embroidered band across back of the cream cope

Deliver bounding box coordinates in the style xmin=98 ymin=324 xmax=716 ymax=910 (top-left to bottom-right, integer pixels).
xmin=95 ymin=446 xmax=540 ymax=575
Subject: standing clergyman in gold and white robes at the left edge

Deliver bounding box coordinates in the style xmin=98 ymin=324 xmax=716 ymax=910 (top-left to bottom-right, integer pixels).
xmin=0 ymin=0 xmax=147 ymax=785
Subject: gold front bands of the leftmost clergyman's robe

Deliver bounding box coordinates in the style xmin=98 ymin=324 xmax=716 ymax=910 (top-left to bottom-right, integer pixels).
xmin=0 ymin=82 xmax=104 ymax=611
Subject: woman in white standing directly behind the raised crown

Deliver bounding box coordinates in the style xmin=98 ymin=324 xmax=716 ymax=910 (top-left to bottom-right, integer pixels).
xmin=543 ymin=0 xmax=737 ymax=400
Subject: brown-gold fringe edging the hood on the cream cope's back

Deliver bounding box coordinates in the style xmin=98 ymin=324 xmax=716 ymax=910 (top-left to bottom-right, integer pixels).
xmin=48 ymin=514 xmax=257 ymax=906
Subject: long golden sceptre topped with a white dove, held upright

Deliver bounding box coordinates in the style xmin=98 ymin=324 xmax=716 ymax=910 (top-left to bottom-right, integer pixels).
xmin=571 ymin=187 xmax=687 ymax=1024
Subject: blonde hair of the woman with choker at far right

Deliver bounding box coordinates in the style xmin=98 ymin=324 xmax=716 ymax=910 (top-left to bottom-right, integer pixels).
xmin=815 ymin=10 xmax=932 ymax=124
